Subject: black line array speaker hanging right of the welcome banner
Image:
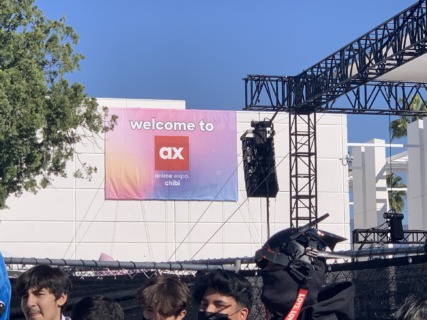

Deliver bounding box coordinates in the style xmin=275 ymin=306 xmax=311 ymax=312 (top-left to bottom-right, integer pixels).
xmin=242 ymin=137 xmax=279 ymax=198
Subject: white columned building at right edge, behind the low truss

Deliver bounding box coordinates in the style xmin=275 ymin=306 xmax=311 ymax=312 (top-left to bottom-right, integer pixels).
xmin=351 ymin=119 xmax=427 ymax=230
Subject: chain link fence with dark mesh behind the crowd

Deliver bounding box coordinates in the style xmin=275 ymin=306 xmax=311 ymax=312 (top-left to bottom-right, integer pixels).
xmin=9 ymin=255 xmax=427 ymax=320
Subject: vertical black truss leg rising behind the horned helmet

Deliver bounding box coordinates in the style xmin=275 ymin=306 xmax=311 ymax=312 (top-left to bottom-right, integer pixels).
xmin=289 ymin=112 xmax=317 ymax=228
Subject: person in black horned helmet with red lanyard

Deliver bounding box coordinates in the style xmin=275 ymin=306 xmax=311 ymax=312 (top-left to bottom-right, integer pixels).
xmin=255 ymin=215 xmax=354 ymax=320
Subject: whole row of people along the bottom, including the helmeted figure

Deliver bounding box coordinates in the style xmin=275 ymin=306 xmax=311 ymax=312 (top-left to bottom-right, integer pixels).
xmin=0 ymin=222 xmax=427 ymax=320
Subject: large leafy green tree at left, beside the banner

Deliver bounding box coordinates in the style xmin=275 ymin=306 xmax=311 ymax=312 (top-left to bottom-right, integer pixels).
xmin=0 ymin=0 xmax=115 ymax=208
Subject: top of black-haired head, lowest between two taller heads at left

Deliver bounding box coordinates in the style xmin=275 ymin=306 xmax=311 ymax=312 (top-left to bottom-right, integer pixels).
xmin=71 ymin=296 xmax=125 ymax=320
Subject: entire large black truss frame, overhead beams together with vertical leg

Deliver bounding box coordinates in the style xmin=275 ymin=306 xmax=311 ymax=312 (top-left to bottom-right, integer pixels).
xmin=244 ymin=0 xmax=427 ymax=226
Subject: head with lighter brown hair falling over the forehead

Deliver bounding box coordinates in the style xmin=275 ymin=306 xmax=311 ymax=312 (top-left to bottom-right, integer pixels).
xmin=137 ymin=274 xmax=190 ymax=320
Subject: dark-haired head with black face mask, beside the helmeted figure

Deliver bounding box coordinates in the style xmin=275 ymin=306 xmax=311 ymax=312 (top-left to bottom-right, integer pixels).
xmin=193 ymin=270 xmax=253 ymax=320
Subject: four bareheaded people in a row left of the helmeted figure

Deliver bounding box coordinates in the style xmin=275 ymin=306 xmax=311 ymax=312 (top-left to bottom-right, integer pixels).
xmin=12 ymin=265 xmax=253 ymax=320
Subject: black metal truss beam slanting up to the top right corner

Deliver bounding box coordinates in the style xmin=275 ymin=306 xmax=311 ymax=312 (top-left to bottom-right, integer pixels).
xmin=244 ymin=0 xmax=427 ymax=113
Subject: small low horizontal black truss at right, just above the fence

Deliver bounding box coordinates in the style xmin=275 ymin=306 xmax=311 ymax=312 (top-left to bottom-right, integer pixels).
xmin=353 ymin=228 xmax=427 ymax=249
